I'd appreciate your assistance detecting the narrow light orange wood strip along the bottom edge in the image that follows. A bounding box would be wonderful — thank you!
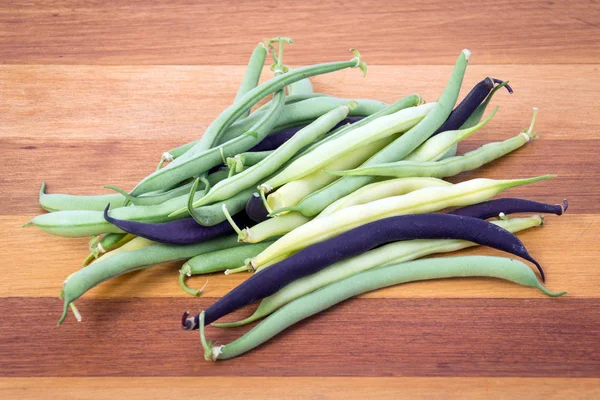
[0,376,600,400]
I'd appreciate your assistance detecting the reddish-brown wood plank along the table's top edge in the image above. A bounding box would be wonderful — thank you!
[0,0,600,65]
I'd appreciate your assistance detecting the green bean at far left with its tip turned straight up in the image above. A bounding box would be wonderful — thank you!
[39,182,127,211]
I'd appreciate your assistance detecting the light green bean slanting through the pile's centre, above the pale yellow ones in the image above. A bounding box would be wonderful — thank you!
[183,105,353,211]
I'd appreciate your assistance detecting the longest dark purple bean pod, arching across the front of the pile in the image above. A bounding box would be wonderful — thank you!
[182,214,544,330]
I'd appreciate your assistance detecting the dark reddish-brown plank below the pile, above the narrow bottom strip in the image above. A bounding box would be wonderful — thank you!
[0,298,600,378]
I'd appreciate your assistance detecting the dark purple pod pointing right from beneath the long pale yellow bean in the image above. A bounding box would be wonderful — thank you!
[449,198,569,219]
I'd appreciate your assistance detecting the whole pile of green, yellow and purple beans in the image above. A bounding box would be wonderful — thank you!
[27,37,568,361]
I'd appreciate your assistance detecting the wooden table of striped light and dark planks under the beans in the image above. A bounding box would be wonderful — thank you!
[0,0,600,400]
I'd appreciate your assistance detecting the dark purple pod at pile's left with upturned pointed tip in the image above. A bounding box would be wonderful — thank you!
[104,204,248,244]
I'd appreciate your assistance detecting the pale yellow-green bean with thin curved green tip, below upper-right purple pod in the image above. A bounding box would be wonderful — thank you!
[403,107,498,162]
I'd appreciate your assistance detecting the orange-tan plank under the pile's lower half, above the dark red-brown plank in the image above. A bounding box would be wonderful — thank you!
[0,214,600,296]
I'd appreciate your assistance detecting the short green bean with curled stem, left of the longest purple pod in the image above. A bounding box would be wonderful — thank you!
[179,242,271,296]
